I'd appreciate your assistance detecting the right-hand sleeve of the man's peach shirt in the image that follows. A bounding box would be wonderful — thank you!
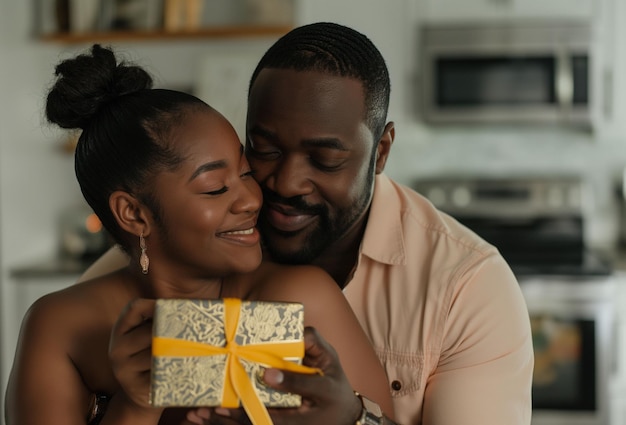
[423,254,534,425]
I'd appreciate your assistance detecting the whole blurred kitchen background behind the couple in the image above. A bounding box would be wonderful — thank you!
[0,0,626,425]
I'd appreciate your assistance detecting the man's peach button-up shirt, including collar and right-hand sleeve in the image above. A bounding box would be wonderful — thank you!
[344,175,533,425]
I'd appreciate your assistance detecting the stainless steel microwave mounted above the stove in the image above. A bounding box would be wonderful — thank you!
[420,21,592,126]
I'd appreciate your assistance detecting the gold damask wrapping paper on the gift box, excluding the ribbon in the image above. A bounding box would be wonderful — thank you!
[151,299,304,407]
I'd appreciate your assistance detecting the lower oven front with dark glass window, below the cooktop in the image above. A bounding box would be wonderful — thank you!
[519,276,616,425]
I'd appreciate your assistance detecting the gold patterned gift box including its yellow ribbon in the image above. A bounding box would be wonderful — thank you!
[150,298,318,423]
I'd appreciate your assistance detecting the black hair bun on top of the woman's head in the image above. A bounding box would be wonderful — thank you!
[46,44,152,129]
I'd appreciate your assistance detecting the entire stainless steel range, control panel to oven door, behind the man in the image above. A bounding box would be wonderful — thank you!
[415,176,617,425]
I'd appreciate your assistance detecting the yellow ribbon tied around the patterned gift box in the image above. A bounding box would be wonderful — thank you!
[152,298,322,425]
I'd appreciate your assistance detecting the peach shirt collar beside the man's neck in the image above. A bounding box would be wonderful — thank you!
[361,174,406,265]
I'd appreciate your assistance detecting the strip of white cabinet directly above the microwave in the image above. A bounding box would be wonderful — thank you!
[422,0,595,23]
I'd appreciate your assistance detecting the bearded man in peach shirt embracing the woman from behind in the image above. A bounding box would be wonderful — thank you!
[81,23,533,425]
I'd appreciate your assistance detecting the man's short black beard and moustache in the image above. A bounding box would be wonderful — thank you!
[258,164,374,264]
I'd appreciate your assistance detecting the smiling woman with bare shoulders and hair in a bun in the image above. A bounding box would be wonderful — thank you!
[7,45,392,425]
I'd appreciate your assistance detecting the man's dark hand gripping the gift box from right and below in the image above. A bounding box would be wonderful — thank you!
[187,327,361,425]
